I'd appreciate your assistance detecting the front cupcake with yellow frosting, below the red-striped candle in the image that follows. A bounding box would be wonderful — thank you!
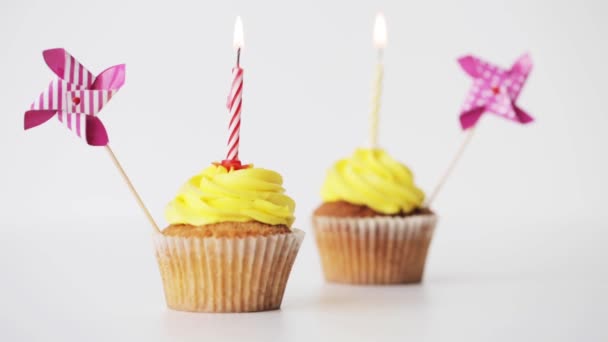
[154,164,304,312]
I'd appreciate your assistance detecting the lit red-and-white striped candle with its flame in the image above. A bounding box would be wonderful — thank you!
[226,17,243,164]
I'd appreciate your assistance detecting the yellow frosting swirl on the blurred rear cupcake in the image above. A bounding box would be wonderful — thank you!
[321,149,424,214]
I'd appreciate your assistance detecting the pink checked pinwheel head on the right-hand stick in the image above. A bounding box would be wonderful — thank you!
[458,54,534,130]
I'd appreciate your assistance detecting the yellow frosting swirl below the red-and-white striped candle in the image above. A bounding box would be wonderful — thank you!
[165,165,295,227]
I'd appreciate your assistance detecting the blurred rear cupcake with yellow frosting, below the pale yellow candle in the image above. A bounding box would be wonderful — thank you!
[313,148,437,284]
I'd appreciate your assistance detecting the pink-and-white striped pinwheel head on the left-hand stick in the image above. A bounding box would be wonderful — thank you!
[24,49,125,146]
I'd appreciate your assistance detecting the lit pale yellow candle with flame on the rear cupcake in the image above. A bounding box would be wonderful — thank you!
[369,13,386,148]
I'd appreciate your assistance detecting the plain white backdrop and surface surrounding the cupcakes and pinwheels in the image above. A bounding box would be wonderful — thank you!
[0,0,608,341]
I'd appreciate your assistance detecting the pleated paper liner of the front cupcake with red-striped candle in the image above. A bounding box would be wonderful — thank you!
[154,229,304,312]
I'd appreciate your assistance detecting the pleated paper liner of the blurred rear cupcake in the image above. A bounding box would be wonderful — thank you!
[313,215,437,285]
